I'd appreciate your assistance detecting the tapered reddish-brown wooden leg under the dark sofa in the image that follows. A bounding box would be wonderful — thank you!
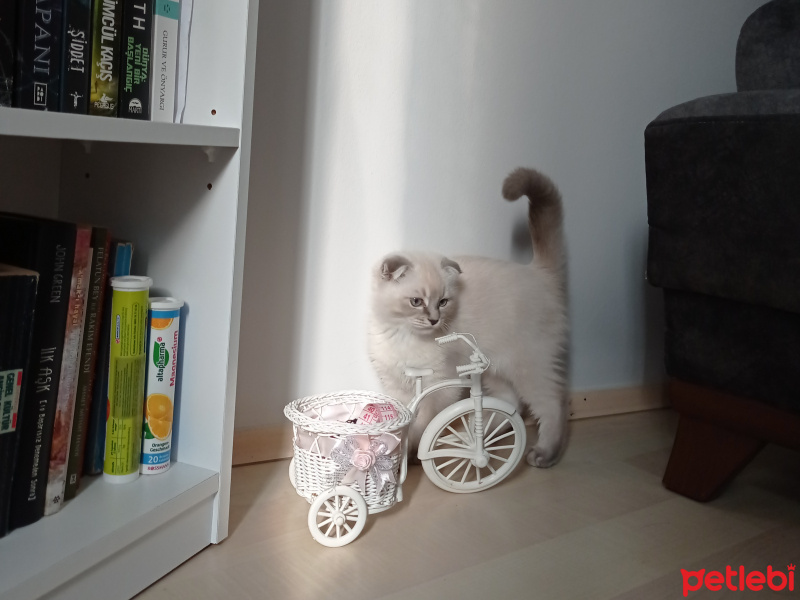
[663,415,765,502]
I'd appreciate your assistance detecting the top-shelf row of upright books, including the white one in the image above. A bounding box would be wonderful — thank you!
[0,0,192,123]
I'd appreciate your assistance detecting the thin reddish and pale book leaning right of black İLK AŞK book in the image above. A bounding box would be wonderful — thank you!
[44,225,92,516]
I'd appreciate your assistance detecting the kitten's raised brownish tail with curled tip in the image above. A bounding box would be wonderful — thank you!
[503,167,566,270]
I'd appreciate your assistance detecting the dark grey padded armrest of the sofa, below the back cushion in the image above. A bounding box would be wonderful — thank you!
[645,90,800,312]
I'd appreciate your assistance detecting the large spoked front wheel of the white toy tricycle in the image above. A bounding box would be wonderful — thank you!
[419,397,526,493]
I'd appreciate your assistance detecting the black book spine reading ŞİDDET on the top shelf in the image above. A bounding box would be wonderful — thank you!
[61,0,92,115]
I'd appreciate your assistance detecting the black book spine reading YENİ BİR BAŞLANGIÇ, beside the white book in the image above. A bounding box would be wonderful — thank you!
[120,0,153,120]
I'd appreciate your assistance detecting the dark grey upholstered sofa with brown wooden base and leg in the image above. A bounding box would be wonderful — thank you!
[645,0,800,501]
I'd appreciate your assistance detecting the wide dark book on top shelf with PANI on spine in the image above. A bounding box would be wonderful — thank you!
[13,0,63,111]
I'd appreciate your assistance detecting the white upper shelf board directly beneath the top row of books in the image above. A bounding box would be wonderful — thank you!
[0,107,240,148]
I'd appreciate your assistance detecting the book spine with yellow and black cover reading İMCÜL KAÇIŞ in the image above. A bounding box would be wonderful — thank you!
[89,0,122,117]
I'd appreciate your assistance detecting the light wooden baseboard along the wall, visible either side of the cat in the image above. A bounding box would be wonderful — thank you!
[233,384,668,466]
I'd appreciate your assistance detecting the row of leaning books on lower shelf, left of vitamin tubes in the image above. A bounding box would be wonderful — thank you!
[0,213,132,537]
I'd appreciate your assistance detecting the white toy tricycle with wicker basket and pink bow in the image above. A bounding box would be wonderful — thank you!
[284,333,526,547]
